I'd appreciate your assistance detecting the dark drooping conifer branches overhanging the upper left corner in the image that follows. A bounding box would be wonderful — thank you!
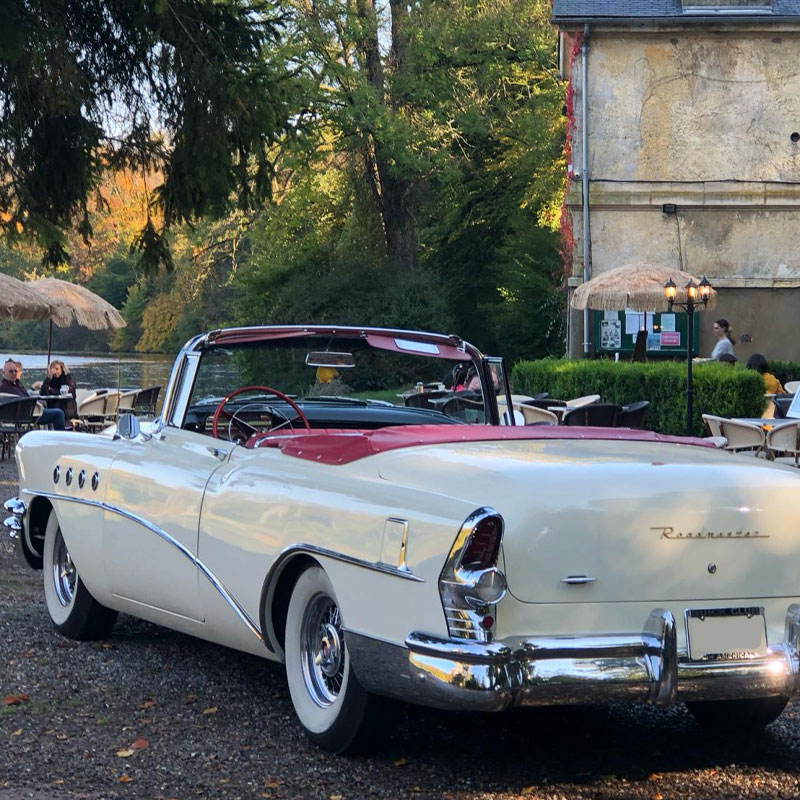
[0,0,294,268]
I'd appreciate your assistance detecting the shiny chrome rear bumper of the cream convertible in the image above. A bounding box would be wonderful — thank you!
[346,605,800,711]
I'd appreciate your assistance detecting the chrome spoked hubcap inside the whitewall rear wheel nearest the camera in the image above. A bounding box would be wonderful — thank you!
[301,595,344,707]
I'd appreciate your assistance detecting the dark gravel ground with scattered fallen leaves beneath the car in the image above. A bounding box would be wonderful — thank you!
[0,461,800,800]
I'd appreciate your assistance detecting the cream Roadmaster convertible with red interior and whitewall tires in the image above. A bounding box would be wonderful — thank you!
[5,326,800,752]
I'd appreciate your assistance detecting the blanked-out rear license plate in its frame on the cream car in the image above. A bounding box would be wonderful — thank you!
[686,606,767,661]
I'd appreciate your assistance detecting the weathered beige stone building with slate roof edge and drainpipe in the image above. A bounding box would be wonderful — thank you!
[552,0,800,361]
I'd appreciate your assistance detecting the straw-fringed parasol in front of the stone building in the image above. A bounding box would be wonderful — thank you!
[570,262,717,311]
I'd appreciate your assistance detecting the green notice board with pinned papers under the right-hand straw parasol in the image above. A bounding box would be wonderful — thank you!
[592,309,699,356]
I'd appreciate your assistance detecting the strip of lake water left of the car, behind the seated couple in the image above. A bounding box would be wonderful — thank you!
[0,352,175,400]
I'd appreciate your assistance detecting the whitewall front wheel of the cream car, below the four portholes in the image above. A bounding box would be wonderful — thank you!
[42,511,117,641]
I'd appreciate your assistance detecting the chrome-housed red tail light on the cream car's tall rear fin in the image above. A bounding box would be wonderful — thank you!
[439,508,507,642]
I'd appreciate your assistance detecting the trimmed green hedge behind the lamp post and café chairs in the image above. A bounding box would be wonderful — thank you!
[511,358,765,436]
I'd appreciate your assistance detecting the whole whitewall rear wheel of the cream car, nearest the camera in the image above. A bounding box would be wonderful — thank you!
[285,567,377,754]
